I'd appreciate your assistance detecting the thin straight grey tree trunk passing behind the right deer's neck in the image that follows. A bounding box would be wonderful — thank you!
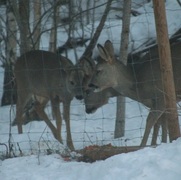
[114,0,131,138]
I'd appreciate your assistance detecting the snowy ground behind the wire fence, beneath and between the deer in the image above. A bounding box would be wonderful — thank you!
[0,86,180,159]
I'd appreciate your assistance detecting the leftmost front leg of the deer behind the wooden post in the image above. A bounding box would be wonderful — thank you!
[140,109,162,147]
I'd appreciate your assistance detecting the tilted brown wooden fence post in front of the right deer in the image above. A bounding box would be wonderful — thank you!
[153,0,180,141]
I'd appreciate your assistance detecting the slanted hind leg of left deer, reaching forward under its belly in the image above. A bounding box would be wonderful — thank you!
[35,102,59,143]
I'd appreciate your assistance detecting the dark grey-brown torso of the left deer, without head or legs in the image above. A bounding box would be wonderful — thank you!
[14,50,80,101]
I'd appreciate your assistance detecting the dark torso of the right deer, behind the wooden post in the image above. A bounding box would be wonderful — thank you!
[130,42,181,102]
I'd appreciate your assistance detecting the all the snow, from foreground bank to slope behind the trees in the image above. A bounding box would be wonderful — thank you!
[0,0,181,180]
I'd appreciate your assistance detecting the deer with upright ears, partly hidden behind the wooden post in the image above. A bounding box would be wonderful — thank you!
[89,40,181,147]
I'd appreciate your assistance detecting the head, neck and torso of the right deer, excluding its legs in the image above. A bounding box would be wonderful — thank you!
[90,42,181,107]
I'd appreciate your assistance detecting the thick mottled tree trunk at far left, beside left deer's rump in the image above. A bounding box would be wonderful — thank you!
[1,1,17,106]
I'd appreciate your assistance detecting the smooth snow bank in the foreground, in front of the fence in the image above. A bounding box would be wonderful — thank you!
[0,139,181,180]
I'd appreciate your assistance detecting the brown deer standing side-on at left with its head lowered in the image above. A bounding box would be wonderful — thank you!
[14,50,83,149]
